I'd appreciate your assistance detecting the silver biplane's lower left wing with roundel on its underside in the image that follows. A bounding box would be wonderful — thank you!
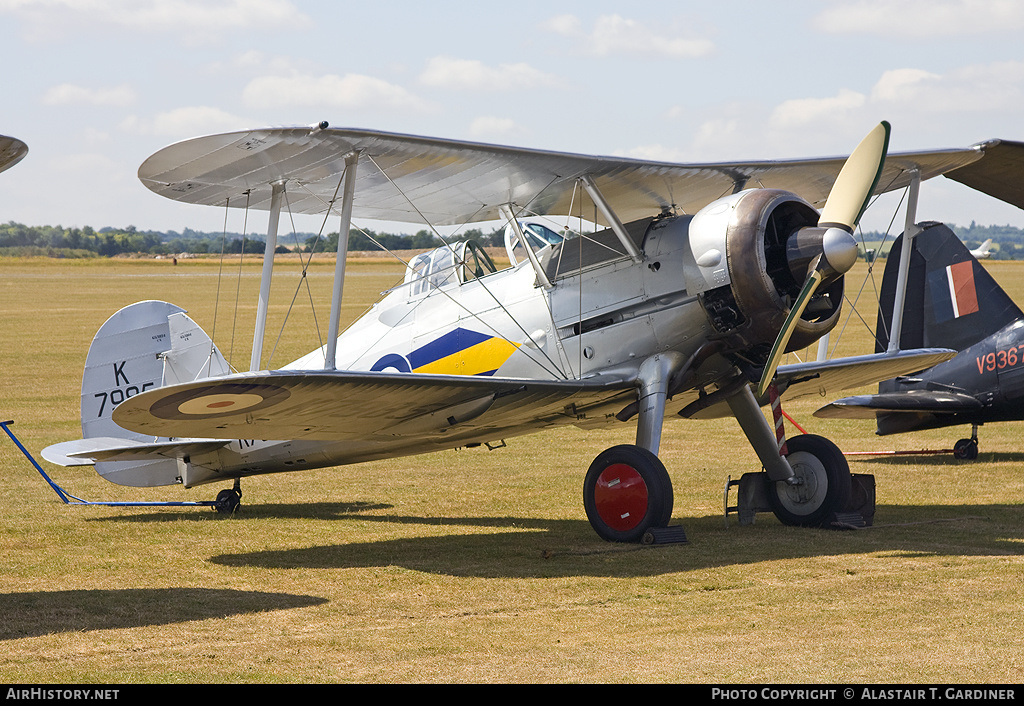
[114,371,636,444]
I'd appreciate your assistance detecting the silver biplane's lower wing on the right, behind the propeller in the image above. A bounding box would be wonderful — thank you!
[761,348,956,404]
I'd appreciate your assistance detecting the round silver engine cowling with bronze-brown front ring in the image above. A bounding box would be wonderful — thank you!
[689,189,844,354]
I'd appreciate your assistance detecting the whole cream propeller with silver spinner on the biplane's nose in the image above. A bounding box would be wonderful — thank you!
[757,121,889,398]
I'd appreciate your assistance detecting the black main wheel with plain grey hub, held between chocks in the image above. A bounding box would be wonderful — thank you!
[768,434,851,527]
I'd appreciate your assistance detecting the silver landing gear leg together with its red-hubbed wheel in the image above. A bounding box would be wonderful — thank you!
[583,352,683,542]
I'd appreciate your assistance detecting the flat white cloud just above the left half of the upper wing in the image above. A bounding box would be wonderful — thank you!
[242,74,430,111]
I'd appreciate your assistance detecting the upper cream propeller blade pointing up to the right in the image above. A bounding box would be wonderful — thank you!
[818,120,890,233]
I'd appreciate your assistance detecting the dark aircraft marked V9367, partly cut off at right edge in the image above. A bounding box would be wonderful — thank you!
[814,222,1024,459]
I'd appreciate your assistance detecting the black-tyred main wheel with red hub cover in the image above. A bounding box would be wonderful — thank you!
[583,444,673,542]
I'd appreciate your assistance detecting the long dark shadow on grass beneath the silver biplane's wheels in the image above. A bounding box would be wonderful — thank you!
[208,505,1024,578]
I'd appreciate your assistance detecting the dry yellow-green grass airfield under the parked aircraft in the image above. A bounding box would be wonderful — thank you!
[0,256,1024,683]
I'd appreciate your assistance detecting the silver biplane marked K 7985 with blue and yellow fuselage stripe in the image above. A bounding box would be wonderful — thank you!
[43,123,1024,541]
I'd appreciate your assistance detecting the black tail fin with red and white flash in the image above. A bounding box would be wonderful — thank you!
[876,222,1024,352]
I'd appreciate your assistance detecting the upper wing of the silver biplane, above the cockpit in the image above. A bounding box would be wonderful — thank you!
[138,128,988,224]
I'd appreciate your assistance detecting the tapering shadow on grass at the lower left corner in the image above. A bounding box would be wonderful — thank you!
[0,588,327,640]
